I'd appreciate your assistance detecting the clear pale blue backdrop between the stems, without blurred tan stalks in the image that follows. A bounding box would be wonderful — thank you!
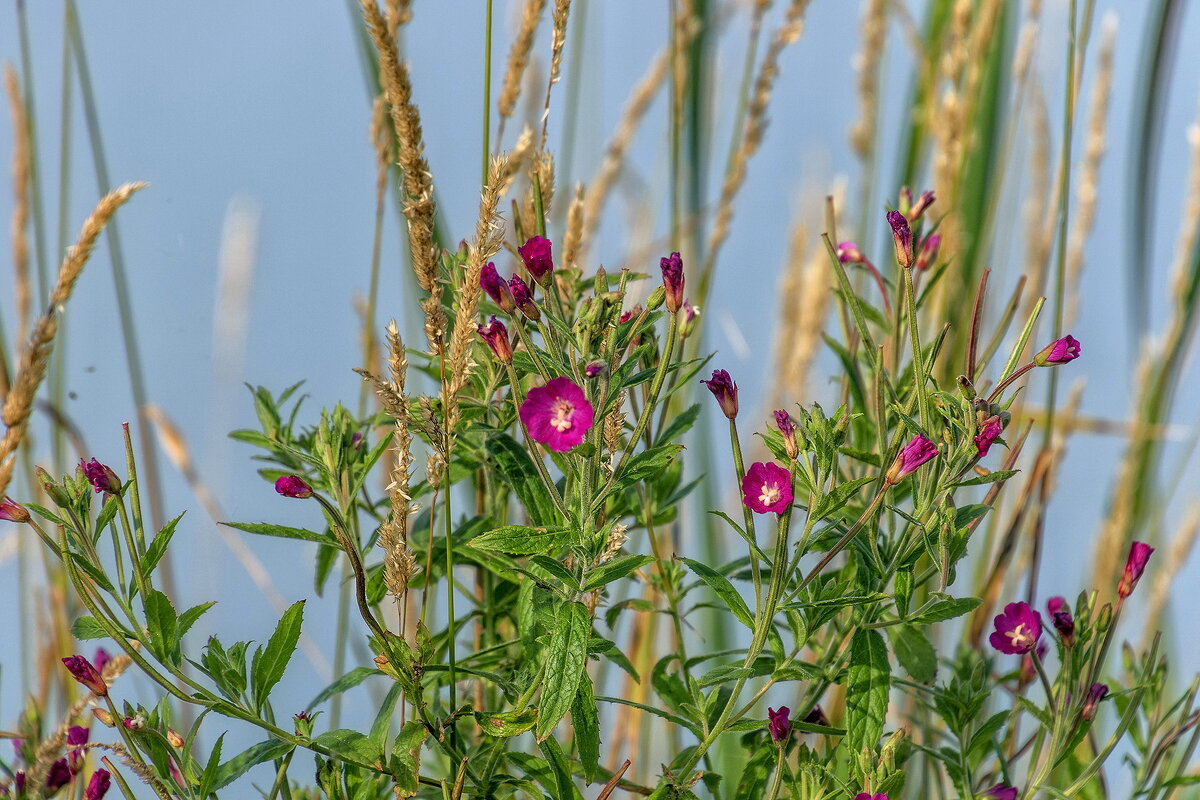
[0,0,1200,796]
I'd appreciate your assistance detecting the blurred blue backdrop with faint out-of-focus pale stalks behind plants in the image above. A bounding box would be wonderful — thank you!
[0,0,1200,786]
